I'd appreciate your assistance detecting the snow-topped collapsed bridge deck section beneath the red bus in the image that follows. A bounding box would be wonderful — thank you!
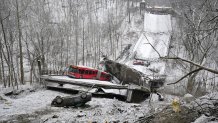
[41,75,150,103]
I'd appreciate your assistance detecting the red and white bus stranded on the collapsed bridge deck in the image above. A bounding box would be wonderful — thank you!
[64,65,111,81]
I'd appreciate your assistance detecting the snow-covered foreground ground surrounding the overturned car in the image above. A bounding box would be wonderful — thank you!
[0,85,177,123]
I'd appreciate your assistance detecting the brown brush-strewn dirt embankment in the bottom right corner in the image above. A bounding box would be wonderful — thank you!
[139,93,218,123]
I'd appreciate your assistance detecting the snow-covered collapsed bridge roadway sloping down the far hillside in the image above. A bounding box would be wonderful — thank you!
[121,13,172,75]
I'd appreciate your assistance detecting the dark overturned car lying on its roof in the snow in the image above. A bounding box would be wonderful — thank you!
[51,93,92,107]
